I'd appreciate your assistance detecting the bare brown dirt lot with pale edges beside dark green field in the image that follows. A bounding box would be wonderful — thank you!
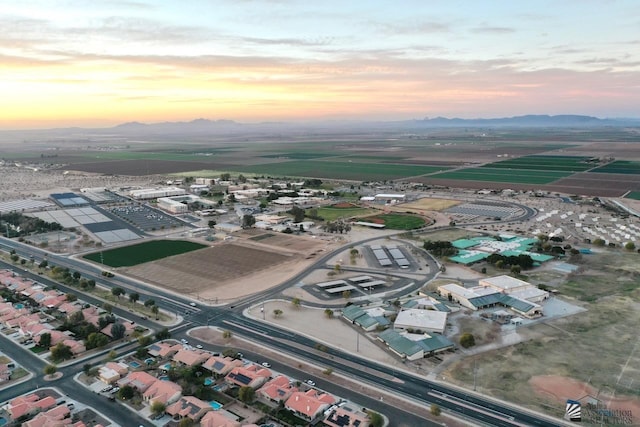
[120,233,327,304]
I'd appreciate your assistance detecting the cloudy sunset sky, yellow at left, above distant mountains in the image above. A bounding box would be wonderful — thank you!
[0,0,640,129]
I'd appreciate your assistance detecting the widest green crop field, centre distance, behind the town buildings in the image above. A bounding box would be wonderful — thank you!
[234,158,446,181]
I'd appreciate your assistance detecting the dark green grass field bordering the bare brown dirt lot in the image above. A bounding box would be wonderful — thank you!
[84,240,207,267]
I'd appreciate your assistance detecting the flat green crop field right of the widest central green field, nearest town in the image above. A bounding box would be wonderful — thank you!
[431,168,572,184]
